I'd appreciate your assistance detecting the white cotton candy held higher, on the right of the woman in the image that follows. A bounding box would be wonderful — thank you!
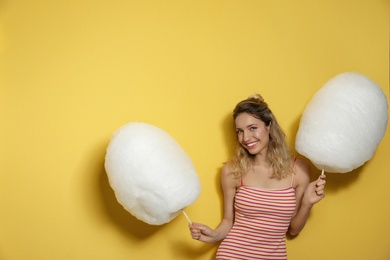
[295,72,388,173]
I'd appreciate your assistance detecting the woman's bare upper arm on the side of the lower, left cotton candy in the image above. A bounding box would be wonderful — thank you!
[221,164,238,222]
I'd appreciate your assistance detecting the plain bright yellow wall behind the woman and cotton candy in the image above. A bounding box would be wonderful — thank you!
[0,0,390,260]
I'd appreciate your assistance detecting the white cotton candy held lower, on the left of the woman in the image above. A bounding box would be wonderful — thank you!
[105,122,201,225]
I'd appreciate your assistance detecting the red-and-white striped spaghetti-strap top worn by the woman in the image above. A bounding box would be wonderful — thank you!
[216,186,296,260]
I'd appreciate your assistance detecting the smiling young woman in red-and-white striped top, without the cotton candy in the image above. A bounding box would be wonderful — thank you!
[189,94,325,259]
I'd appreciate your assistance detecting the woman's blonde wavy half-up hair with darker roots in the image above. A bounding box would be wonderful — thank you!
[227,94,293,180]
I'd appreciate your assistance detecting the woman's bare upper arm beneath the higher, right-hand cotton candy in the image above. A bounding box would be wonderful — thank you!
[294,159,311,215]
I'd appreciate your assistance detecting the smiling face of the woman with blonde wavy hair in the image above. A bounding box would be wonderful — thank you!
[235,113,271,155]
